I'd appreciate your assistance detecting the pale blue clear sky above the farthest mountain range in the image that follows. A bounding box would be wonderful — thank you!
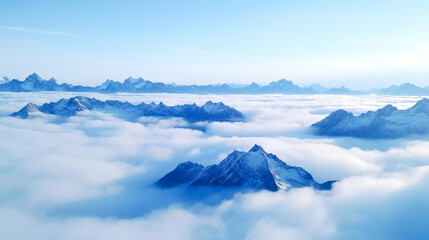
[0,0,429,89]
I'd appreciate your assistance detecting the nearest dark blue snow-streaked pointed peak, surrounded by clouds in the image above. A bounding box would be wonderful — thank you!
[155,145,335,191]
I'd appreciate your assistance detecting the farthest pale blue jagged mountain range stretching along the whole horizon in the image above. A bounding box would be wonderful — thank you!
[0,73,429,95]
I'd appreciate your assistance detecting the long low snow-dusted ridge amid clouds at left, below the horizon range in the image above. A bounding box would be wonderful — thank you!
[11,96,244,123]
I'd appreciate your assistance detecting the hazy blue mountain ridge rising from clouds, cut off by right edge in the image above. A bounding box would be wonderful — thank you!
[312,98,429,138]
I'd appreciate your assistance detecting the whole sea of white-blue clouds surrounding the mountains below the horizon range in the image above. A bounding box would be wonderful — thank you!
[0,92,429,239]
